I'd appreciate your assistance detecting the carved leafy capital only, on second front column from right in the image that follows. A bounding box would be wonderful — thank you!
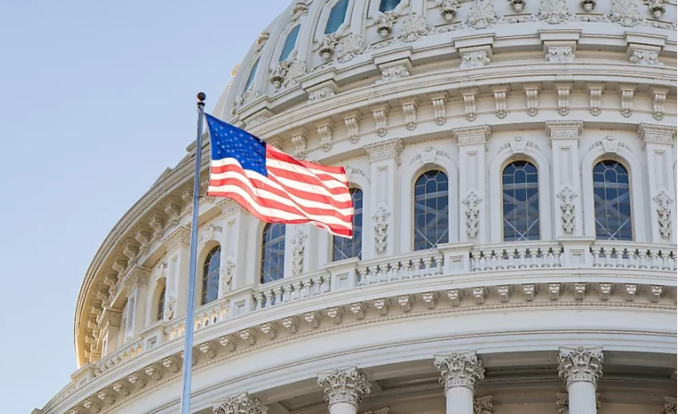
[434,351,485,390]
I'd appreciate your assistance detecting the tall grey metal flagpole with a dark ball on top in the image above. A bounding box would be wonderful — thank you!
[181,92,206,414]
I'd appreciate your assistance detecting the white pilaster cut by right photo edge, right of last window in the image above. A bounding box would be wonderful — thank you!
[637,124,676,244]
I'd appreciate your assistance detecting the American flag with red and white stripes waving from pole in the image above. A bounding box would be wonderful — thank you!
[205,115,353,238]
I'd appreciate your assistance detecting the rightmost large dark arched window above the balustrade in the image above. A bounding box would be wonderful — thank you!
[593,160,633,240]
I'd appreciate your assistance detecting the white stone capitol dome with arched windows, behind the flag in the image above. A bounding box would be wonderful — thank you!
[36,0,678,414]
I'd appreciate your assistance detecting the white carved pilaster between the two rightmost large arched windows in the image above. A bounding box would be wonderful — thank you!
[545,121,584,239]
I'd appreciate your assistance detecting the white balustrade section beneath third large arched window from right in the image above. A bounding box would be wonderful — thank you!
[358,250,444,286]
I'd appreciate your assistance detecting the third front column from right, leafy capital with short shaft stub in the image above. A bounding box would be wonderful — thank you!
[318,367,370,414]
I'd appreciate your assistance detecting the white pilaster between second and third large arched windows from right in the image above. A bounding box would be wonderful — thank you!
[452,125,492,243]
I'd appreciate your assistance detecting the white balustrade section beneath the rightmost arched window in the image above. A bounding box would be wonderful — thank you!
[590,242,676,270]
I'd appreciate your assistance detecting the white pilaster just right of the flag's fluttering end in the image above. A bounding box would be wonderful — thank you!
[363,138,403,260]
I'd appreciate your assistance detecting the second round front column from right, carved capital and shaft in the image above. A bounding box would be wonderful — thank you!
[434,351,485,414]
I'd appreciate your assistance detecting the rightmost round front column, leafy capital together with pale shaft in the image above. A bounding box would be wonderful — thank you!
[558,347,603,414]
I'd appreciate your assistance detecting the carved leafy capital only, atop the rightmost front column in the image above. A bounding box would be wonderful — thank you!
[558,346,603,386]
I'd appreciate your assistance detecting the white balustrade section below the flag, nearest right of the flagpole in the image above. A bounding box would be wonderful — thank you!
[252,270,332,309]
